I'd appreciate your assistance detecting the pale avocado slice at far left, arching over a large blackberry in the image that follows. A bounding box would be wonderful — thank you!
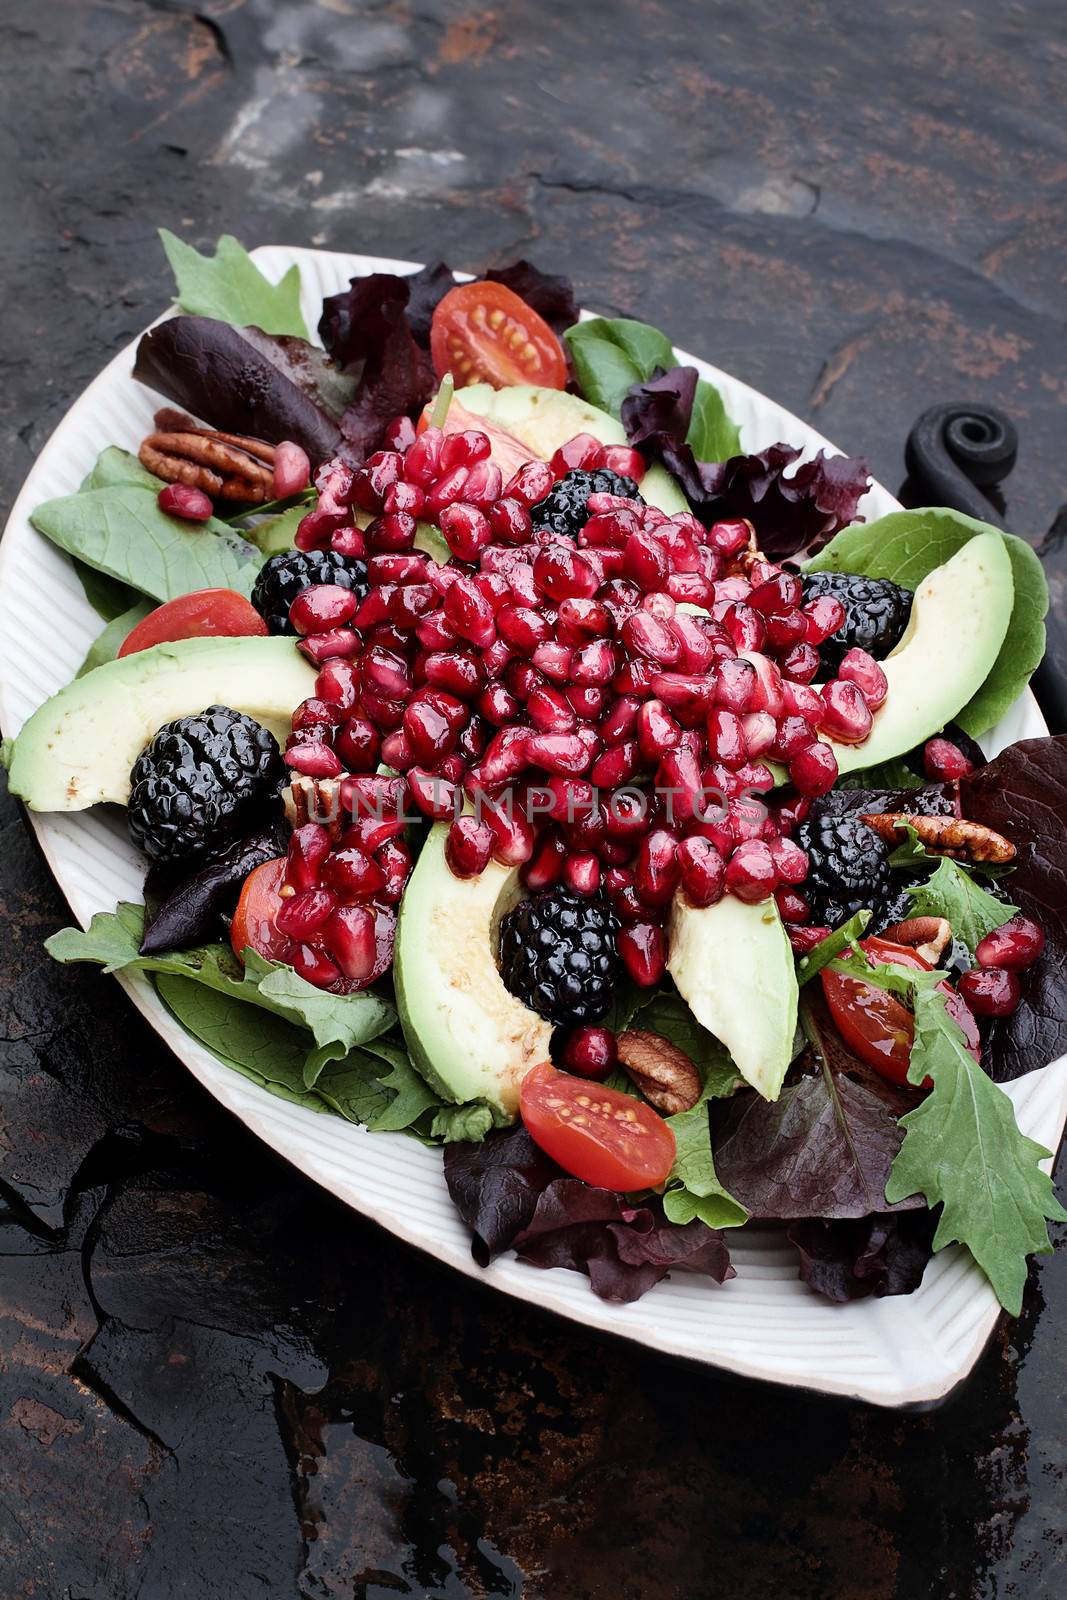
[5,638,315,811]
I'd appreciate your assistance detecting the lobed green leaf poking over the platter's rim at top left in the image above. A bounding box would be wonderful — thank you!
[160,227,307,339]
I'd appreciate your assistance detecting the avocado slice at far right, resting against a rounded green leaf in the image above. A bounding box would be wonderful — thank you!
[833,531,1014,773]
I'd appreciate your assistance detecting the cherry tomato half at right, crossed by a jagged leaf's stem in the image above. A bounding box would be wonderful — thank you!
[822,938,981,1088]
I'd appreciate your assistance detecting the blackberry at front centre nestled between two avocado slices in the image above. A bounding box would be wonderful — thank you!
[499,890,619,1027]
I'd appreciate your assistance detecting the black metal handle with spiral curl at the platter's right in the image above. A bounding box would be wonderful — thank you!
[904,400,1067,733]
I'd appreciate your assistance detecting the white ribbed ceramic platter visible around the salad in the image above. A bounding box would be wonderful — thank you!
[0,246,1067,1406]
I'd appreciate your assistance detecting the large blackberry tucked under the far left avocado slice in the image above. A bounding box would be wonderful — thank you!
[128,706,285,862]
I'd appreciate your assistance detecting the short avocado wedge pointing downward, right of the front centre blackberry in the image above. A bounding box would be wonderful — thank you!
[667,893,798,1099]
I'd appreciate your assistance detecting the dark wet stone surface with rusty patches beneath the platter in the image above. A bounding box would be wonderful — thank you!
[0,0,1067,1600]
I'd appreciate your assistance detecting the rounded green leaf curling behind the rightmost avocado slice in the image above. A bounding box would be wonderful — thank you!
[806,507,1048,736]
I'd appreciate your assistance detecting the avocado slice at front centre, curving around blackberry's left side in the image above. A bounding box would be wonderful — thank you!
[394,822,552,1120]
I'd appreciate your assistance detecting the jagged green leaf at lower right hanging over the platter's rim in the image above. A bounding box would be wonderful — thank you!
[886,987,1067,1317]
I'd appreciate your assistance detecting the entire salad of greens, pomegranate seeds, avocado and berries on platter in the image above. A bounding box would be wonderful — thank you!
[3,234,1067,1312]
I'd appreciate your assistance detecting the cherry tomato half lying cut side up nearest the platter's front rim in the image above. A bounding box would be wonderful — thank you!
[518,1061,675,1194]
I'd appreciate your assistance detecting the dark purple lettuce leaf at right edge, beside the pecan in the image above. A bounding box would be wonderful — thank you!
[960,734,1067,1083]
